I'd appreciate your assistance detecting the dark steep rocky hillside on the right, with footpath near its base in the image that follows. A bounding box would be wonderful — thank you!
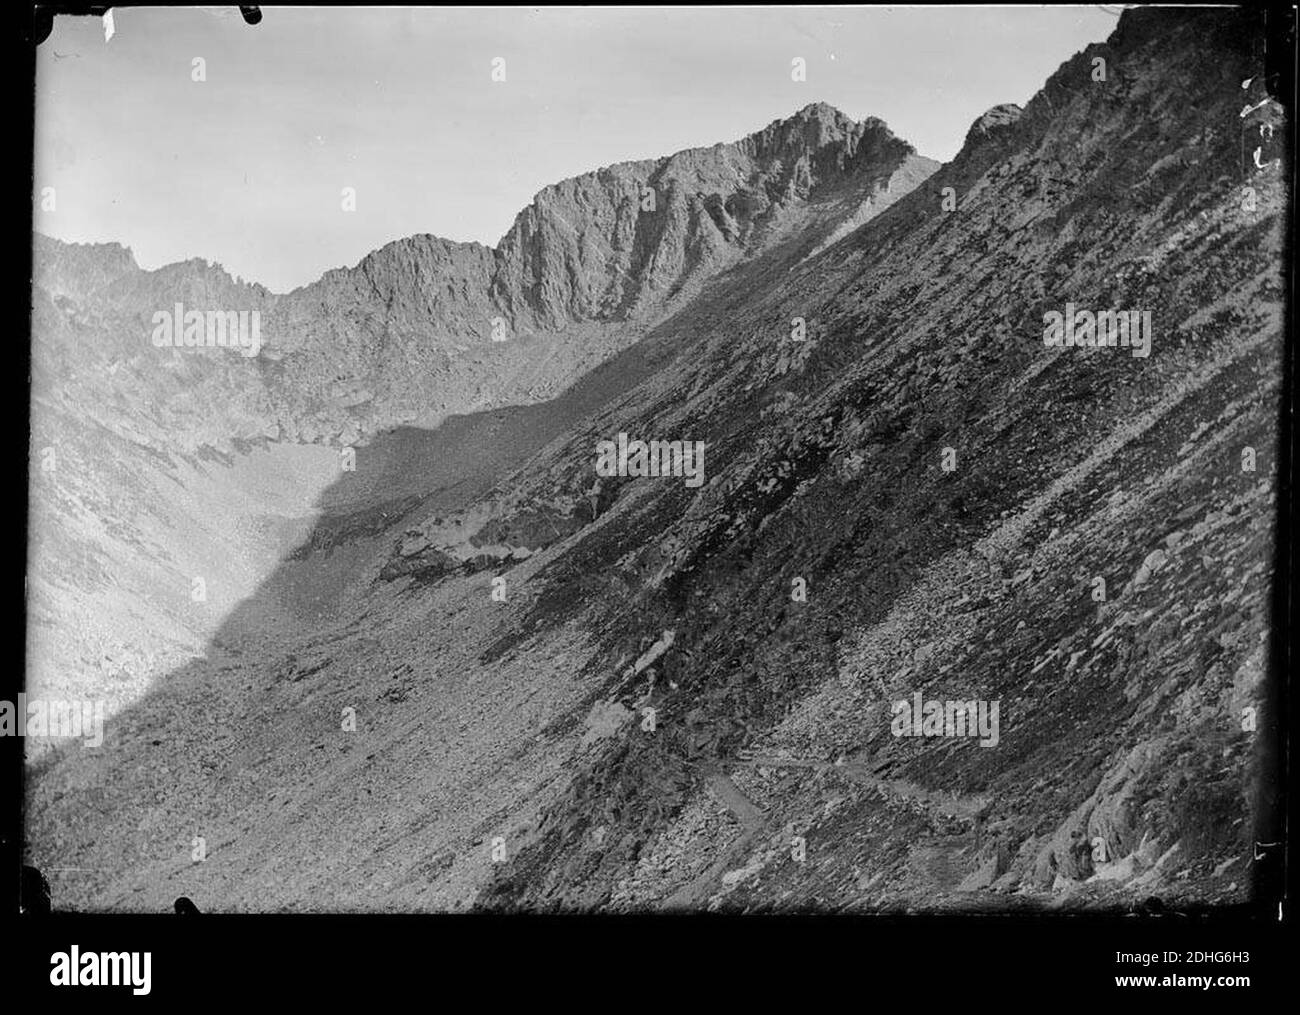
[460,5,1286,908]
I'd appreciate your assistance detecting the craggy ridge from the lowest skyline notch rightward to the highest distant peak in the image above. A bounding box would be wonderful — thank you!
[258,105,937,441]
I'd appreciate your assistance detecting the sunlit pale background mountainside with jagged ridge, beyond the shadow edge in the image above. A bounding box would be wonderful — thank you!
[29,105,937,743]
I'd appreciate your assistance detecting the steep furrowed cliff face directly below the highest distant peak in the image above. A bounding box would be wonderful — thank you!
[494,103,937,326]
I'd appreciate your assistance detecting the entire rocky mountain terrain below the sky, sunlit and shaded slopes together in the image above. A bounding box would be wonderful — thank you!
[27,9,1291,912]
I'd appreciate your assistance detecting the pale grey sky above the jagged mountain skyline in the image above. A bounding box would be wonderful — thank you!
[34,6,1117,291]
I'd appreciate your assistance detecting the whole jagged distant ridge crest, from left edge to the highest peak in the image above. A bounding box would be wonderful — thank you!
[34,104,937,451]
